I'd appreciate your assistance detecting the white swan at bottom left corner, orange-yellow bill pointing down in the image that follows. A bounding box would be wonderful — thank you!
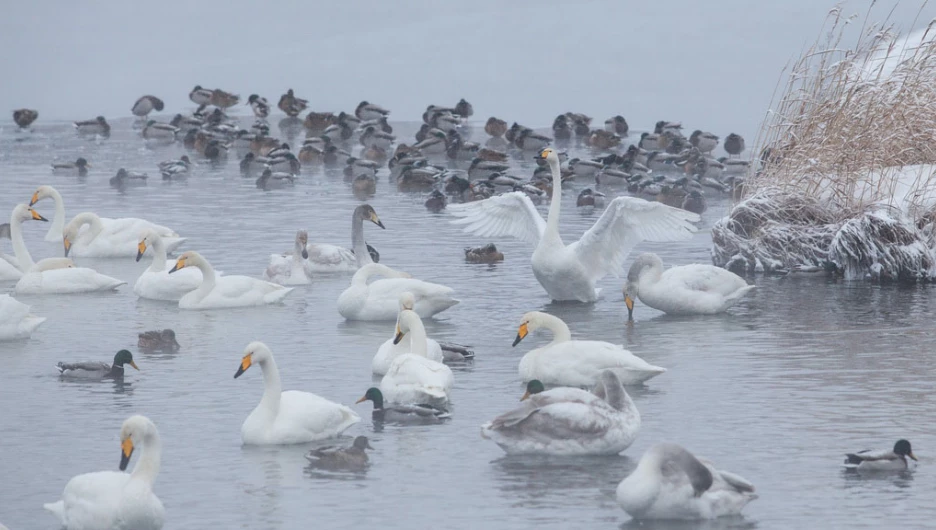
[45,416,166,530]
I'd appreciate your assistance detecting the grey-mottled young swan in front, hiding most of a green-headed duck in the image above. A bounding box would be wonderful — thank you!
[481,370,640,455]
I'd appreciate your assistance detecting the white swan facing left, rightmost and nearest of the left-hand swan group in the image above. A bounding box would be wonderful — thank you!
[169,250,293,309]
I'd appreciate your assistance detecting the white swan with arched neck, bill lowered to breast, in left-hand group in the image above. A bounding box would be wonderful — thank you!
[62,212,185,258]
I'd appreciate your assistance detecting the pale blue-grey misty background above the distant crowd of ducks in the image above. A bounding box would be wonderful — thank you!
[0,0,936,136]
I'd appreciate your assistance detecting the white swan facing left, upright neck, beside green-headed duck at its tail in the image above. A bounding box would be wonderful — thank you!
[234,342,361,445]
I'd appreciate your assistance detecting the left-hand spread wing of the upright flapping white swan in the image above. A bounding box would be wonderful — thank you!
[448,191,546,244]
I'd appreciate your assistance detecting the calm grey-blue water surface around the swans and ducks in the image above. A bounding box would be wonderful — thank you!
[0,117,936,530]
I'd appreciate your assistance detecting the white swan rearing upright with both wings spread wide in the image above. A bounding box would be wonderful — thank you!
[449,148,699,302]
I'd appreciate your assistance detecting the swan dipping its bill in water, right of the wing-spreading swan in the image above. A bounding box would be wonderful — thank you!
[624,253,754,320]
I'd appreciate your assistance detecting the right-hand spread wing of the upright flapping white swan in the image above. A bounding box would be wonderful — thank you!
[568,197,699,282]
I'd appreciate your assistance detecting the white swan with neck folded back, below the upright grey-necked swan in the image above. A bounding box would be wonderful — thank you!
[338,263,458,320]
